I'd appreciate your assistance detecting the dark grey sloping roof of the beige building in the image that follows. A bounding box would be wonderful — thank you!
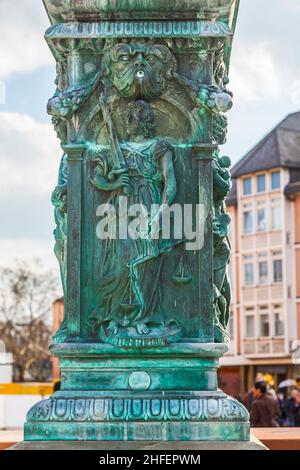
[229,112,300,180]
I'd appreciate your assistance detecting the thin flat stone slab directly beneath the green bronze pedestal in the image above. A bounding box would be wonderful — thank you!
[8,436,268,451]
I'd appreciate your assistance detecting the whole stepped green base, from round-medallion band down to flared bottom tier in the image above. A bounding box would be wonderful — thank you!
[25,344,250,441]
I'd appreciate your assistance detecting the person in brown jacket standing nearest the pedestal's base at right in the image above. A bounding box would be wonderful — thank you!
[250,382,279,428]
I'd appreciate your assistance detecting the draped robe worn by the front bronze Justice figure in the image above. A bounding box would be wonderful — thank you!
[90,139,176,327]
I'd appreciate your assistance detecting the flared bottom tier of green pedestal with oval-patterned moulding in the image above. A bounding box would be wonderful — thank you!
[25,391,250,441]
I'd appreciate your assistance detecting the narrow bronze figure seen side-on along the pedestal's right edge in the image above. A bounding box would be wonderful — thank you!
[213,155,231,342]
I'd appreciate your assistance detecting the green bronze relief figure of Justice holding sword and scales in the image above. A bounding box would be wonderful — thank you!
[90,100,183,346]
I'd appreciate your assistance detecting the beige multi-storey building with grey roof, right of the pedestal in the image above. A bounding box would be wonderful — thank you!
[220,112,300,395]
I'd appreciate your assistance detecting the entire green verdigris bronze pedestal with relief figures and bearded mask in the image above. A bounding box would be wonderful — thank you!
[25,0,249,441]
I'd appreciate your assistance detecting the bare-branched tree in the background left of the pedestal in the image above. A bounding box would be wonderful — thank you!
[0,261,61,381]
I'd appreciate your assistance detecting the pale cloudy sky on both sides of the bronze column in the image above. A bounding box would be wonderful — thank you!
[0,0,300,266]
